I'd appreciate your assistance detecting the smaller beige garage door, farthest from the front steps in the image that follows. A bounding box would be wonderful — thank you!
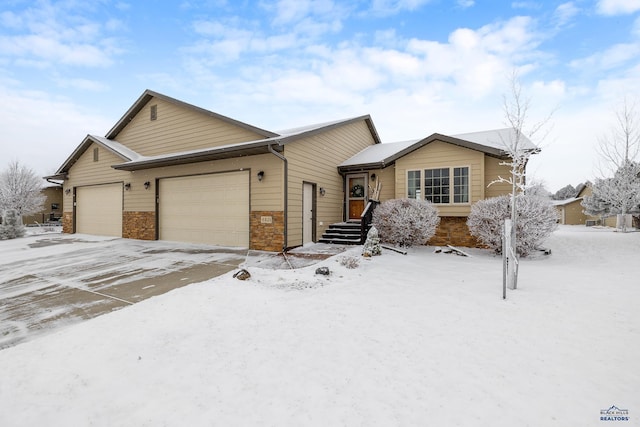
[76,183,122,237]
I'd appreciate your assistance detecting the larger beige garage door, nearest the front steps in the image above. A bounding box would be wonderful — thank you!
[158,171,249,248]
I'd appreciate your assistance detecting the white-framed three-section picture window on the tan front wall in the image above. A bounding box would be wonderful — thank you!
[407,166,469,204]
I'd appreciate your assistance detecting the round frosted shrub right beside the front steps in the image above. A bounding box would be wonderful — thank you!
[373,199,440,247]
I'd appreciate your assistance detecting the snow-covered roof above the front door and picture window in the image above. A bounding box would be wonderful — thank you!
[338,128,539,172]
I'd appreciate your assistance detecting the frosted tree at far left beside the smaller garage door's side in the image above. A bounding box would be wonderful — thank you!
[0,161,45,221]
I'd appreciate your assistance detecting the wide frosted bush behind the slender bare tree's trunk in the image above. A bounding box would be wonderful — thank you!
[467,194,558,256]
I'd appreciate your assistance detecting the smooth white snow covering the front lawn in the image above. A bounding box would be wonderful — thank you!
[0,226,640,426]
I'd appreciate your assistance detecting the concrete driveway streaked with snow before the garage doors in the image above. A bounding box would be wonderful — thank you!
[0,234,246,349]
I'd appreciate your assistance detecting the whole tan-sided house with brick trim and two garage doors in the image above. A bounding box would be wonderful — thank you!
[47,90,535,251]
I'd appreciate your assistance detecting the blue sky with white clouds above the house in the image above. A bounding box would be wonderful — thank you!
[0,0,640,191]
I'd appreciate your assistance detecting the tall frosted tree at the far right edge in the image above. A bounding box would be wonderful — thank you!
[592,98,640,232]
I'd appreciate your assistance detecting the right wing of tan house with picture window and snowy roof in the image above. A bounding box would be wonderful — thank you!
[338,129,538,246]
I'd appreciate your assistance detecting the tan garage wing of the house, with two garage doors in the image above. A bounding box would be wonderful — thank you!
[47,90,380,251]
